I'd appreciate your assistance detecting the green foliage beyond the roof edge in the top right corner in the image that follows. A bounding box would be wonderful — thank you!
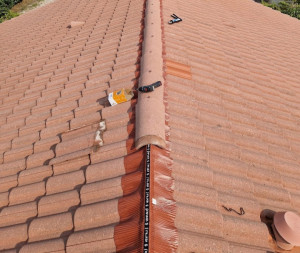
[262,0,300,19]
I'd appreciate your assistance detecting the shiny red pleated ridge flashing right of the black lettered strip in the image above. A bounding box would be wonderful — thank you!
[149,145,178,253]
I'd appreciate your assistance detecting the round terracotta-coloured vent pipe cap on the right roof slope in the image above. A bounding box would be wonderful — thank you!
[272,211,300,250]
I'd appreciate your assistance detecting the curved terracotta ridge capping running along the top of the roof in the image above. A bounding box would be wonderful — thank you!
[135,0,166,149]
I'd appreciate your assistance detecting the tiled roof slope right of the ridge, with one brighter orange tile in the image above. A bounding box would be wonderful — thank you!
[162,0,300,253]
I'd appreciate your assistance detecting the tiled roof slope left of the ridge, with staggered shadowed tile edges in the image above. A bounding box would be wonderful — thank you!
[0,0,144,253]
